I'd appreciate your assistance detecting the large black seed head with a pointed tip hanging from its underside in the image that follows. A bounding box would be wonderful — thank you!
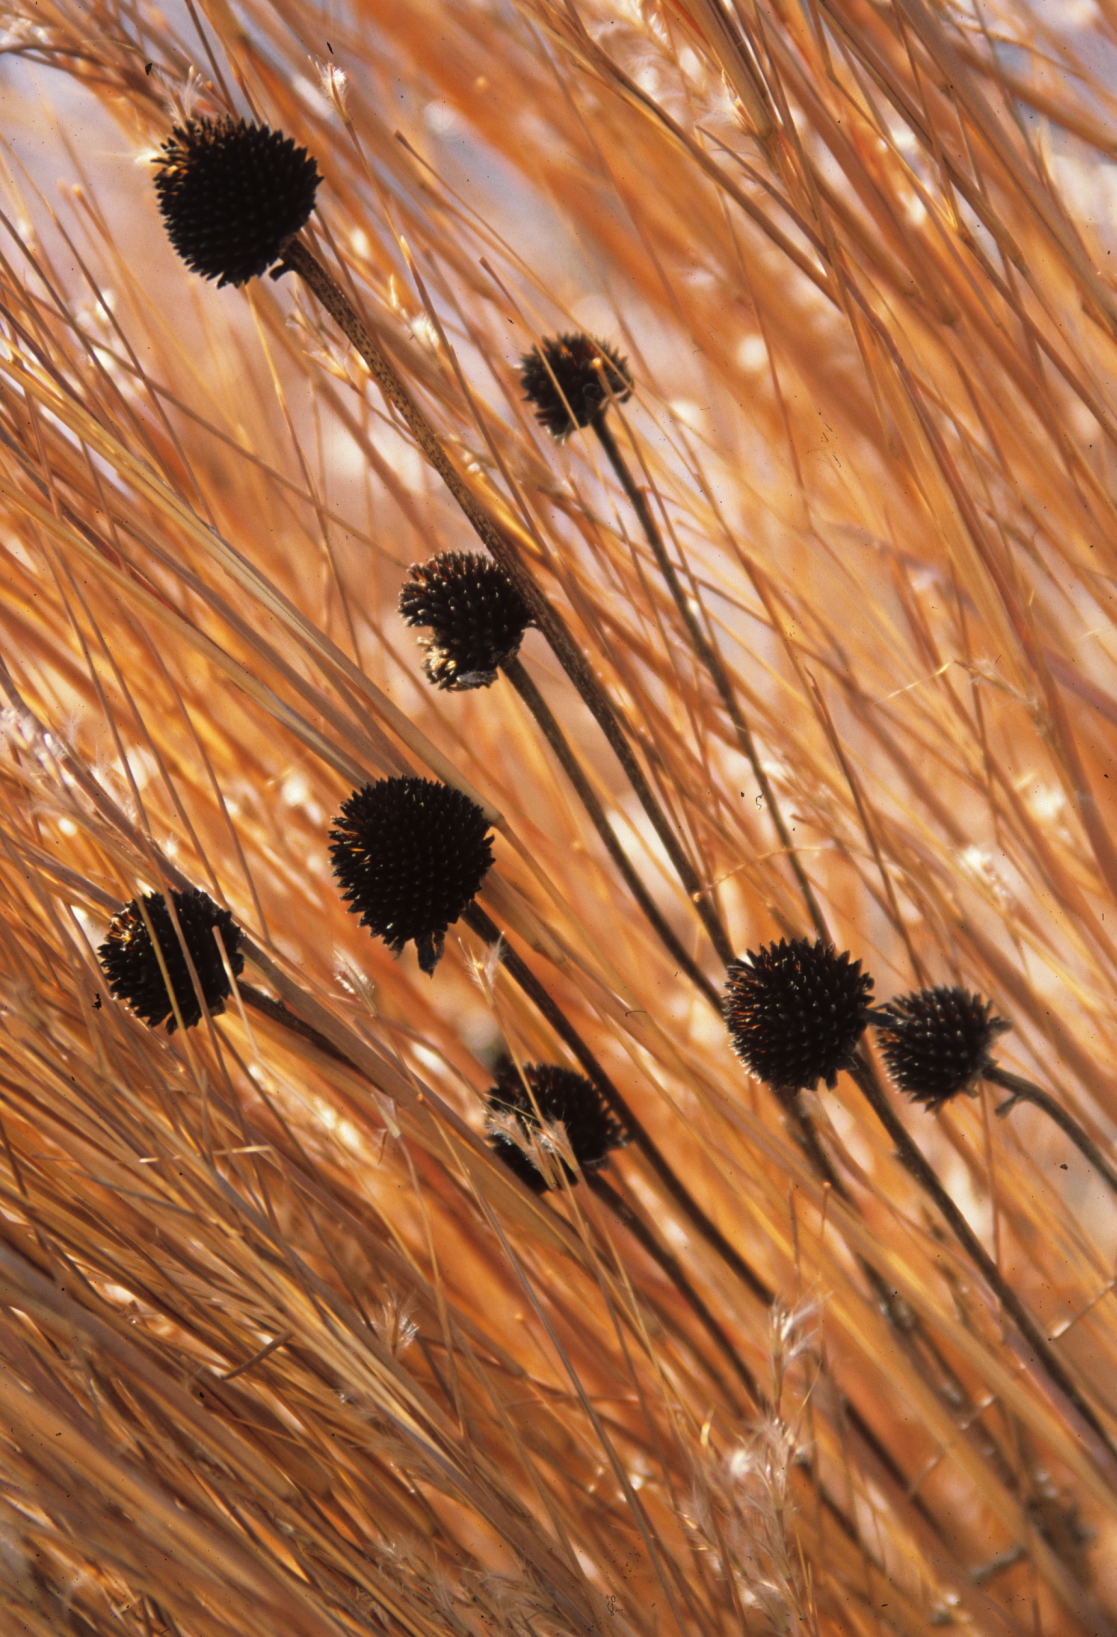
[329,779,493,972]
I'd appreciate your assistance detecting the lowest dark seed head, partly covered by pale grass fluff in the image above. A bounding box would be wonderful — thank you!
[488,1062,627,1193]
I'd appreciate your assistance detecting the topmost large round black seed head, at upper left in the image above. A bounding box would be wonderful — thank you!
[156,115,321,285]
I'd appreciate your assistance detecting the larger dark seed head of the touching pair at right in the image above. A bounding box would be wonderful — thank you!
[724,938,873,1092]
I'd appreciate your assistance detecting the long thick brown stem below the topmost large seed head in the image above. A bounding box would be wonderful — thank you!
[280,236,732,966]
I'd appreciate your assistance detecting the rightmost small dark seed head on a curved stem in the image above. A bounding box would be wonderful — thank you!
[876,987,1012,1108]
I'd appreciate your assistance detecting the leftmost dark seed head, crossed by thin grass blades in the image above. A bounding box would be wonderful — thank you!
[97,887,244,1035]
